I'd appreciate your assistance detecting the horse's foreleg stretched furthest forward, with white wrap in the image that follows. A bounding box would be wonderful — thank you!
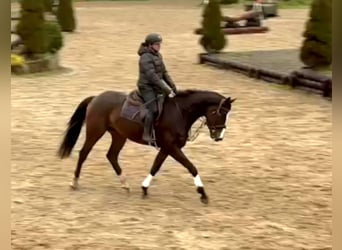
[170,147,208,204]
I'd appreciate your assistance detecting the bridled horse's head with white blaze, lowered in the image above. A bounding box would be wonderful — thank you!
[205,97,236,141]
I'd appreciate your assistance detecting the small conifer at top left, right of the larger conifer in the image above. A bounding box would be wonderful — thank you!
[57,0,76,32]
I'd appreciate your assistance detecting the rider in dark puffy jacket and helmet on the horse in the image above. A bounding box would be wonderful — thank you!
[137,33,177,143]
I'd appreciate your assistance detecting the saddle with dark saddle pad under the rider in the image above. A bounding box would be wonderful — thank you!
[120,90,165,125]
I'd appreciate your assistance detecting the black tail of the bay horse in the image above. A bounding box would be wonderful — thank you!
[57,96,95,159]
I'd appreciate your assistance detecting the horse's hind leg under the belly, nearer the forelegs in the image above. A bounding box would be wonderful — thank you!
[107,130,130,192]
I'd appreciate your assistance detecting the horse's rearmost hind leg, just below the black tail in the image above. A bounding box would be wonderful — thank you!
[70,120,106,189]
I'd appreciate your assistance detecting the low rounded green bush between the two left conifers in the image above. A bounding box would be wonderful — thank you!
[45,21,64,53]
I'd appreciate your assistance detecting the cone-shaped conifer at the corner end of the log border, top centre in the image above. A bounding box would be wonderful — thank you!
[200,0,227,53]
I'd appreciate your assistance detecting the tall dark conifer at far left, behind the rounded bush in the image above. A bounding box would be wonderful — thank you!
[16,0,47,55]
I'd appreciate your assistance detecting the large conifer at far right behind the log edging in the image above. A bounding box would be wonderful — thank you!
[300,0,332,68]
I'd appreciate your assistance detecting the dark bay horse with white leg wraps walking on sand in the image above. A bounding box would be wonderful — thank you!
[58,90,235,203]
